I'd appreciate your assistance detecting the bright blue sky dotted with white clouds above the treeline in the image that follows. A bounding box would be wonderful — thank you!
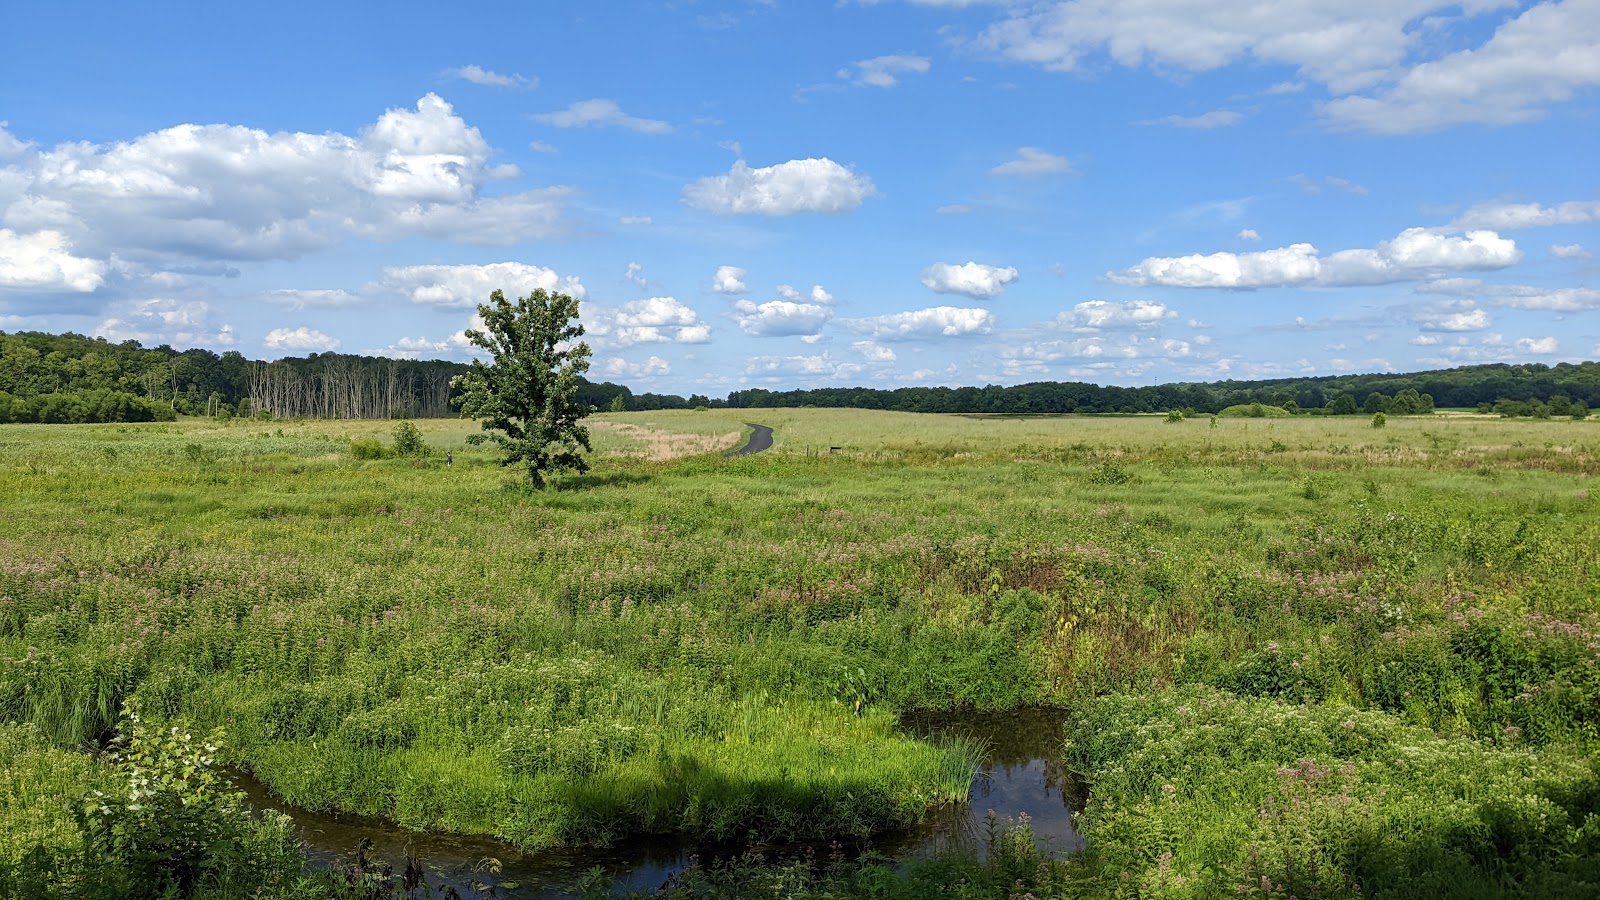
[0,0,1600,394]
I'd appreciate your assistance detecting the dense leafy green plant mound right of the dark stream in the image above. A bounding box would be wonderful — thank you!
[1067,689,1600,897]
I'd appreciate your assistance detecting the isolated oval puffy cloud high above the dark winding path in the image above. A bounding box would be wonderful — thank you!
[683,157,877,216]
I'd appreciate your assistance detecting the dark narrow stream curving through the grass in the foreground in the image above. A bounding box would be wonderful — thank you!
[238,709,1085,900]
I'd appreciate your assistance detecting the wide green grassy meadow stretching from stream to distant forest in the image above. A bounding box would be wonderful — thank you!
[0,410,1600,897]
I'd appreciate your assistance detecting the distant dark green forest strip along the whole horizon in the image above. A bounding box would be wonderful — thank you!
[0,331,1600,423]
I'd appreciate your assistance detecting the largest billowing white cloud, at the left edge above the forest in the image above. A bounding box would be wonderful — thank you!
[0,94,570,263]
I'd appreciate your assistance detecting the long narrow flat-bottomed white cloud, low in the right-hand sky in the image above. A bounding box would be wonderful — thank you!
[1106,227,1522,288]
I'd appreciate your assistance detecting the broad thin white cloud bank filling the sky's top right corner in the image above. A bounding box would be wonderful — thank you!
[947,0,1600,133]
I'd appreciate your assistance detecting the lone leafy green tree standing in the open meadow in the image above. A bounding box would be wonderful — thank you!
[453,288,594,487]
